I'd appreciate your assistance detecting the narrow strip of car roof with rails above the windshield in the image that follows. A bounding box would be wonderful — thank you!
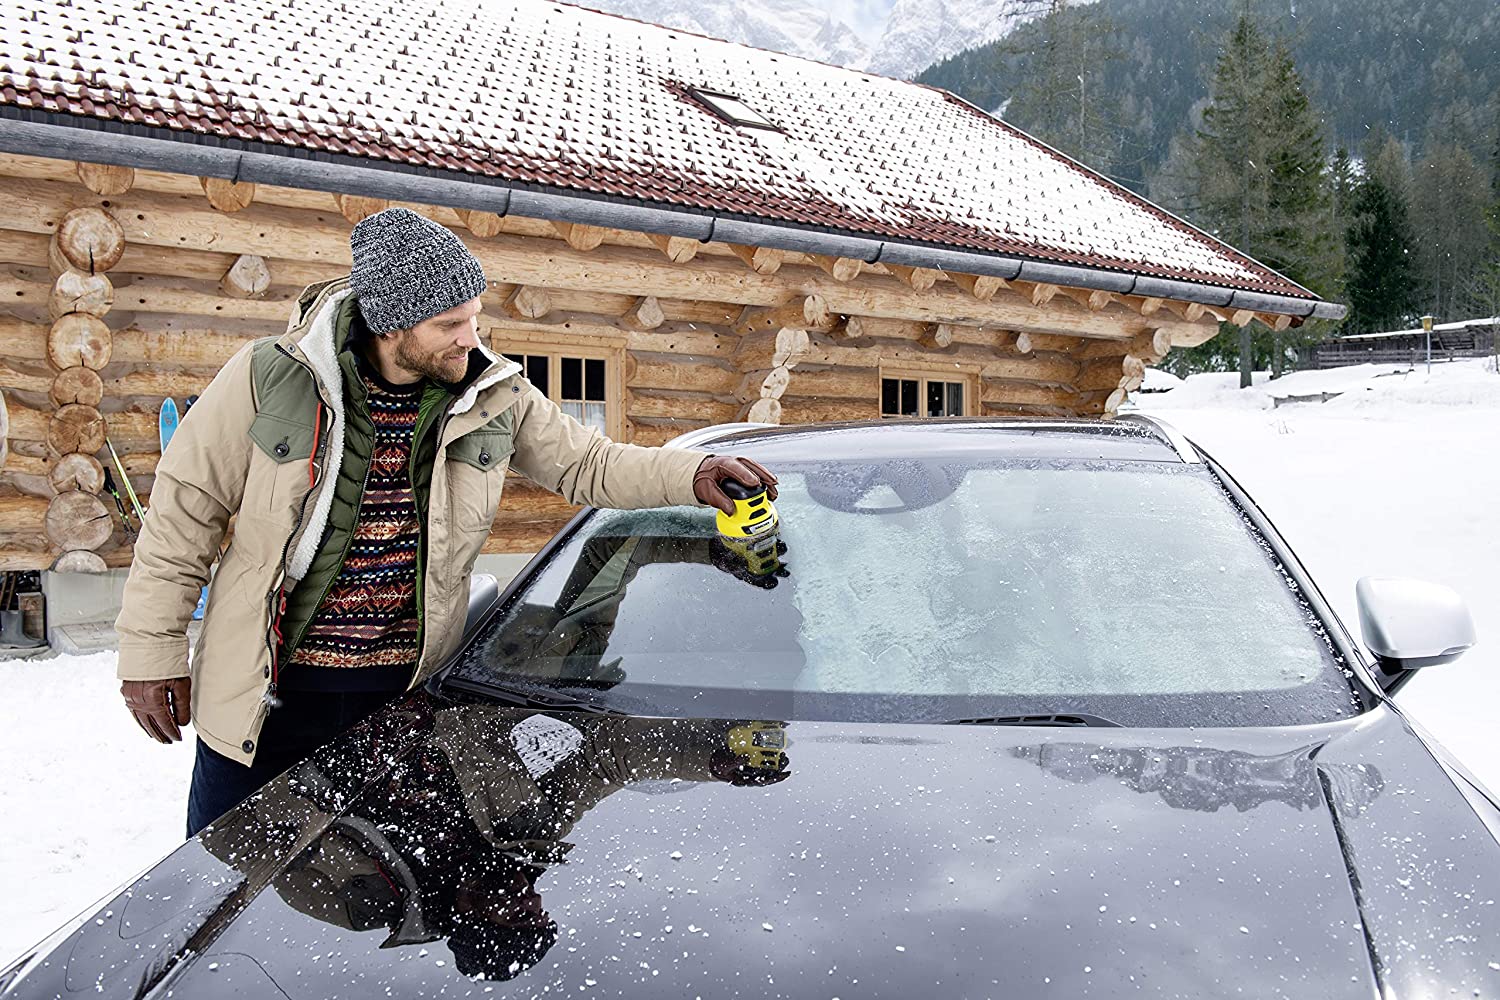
[668,414,1202,463]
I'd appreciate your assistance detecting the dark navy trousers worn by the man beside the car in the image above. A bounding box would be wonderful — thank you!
[188,691,399,838]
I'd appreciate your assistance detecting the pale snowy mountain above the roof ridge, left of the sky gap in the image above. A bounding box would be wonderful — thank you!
[564,0,870,69]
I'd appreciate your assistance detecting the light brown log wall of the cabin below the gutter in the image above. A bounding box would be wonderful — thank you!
[0,154,1224,571]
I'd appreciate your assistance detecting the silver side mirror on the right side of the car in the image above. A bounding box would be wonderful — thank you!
[1355,576,1476,691]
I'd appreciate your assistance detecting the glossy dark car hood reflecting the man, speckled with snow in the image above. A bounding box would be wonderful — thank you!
[12,696,1500,999]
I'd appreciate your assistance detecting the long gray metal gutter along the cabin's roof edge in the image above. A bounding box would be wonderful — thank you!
[0,116,1349,319]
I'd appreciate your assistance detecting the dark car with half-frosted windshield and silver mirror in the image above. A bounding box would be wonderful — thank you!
[0,415,1500,1000]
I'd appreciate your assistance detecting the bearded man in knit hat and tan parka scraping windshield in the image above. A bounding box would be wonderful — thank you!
[117,208,776,835]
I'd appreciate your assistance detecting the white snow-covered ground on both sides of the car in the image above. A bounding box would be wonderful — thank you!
[0,363,1500,964]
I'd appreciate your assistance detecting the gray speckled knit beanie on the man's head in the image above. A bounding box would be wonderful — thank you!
[350,208,486,333]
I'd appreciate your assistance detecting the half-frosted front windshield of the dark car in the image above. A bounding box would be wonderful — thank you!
[446,433,1359,726]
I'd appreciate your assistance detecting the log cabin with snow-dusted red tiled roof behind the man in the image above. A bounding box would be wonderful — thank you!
[0,0,1343,573]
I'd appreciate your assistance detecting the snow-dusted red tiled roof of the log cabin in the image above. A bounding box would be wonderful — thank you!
[0,0,1313,298]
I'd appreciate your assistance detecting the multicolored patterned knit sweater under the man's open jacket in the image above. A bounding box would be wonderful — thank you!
[287,363,426,690]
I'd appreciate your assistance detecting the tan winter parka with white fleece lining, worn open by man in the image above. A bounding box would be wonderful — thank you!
[116,277,704,765]
